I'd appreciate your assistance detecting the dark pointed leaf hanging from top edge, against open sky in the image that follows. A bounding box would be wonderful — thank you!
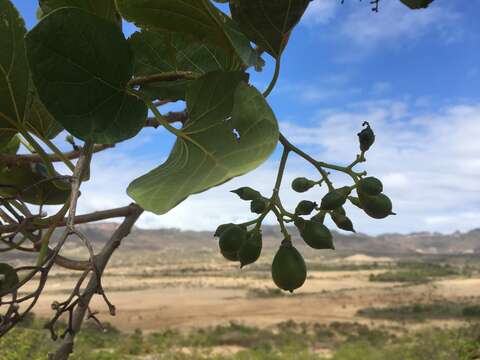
[230,0,311,58]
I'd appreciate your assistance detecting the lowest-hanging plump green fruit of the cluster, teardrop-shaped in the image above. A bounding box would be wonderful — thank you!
[272,240,307,292]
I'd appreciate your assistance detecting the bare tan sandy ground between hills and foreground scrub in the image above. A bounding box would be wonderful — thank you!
[25,254,480,331]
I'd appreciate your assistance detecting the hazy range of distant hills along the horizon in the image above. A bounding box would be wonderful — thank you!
[7,223,480,261]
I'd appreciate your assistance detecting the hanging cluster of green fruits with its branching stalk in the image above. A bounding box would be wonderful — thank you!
[214,122,394,292]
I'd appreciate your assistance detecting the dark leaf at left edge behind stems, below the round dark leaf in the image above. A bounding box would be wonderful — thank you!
[0,163,70,205]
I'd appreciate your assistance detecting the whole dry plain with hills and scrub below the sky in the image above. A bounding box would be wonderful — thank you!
[0,224,480,359]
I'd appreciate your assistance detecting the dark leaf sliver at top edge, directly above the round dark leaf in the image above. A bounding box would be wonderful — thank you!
[39,0,122,27]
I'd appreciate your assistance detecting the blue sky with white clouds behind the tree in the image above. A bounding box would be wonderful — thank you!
[13,0,480,235]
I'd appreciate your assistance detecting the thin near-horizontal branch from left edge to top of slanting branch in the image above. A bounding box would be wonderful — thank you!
[0,206,137,234]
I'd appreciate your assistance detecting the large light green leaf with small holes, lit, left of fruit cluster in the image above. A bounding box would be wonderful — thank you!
[128,72,278,214]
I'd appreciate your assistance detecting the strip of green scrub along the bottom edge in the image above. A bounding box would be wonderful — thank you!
[0,321,480,360]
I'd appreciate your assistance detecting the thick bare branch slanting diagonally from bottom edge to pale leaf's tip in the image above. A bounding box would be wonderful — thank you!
[49,204,143,360]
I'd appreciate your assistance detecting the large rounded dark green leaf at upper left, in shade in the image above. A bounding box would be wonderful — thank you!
[26,8,147,144]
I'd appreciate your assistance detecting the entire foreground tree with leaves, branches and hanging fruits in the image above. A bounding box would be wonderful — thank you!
[0,0,433,359]
